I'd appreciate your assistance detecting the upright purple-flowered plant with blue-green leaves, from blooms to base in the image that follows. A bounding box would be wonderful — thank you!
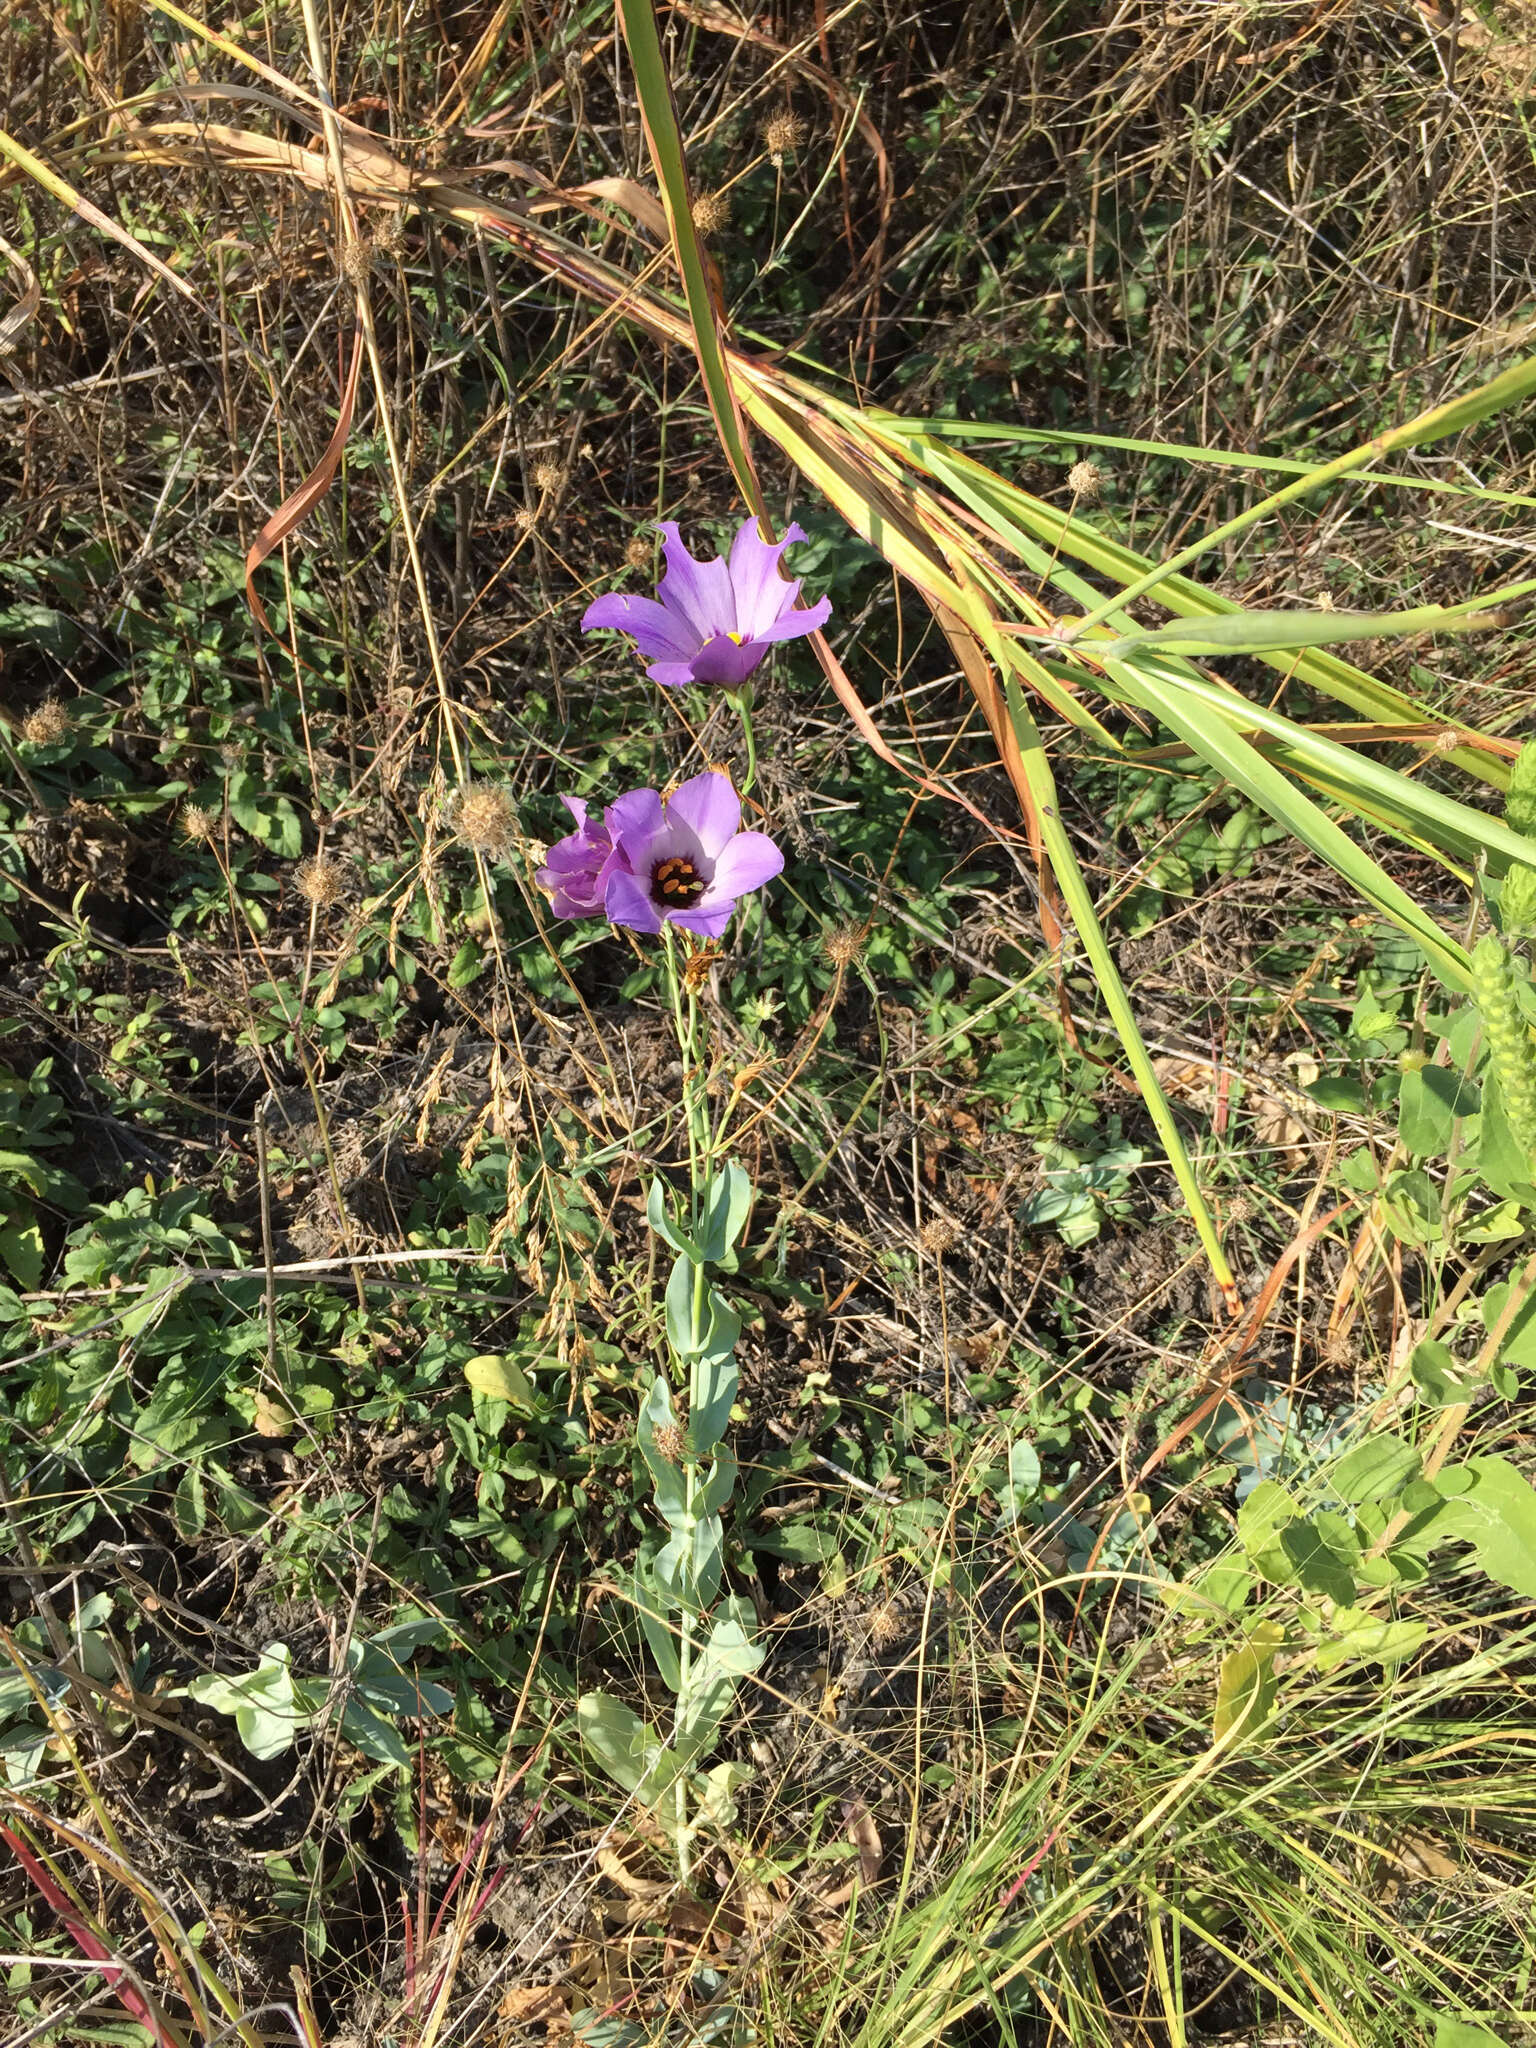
[539,518,811,1872]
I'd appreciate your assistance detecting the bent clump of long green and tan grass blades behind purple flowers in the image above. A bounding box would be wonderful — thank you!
[99,0,1536,1311]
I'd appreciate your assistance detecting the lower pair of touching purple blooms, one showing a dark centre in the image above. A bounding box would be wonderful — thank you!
[539,768,784,938]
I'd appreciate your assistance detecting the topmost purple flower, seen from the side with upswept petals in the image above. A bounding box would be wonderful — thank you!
[582,518,831,688]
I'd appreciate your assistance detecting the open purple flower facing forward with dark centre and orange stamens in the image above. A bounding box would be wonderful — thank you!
[604,770,784,938]
